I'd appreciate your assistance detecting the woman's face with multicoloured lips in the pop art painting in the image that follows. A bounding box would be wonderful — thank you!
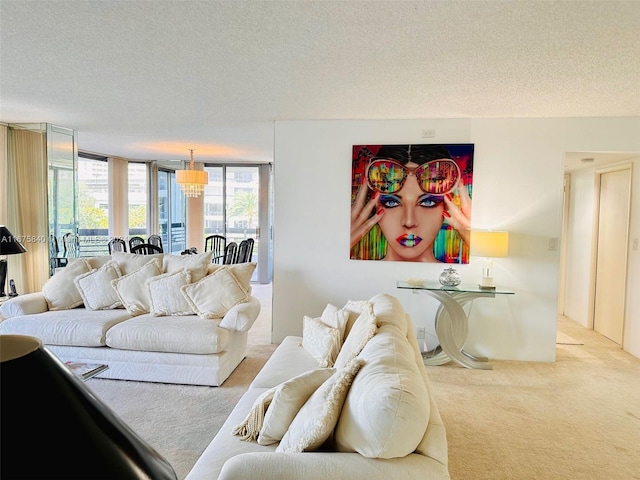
[378,163,444,262]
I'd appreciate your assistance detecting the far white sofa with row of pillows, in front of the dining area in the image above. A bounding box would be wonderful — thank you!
[0,252,260,386]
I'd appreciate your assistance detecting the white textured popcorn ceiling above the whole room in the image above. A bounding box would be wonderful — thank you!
[0,0,640,167]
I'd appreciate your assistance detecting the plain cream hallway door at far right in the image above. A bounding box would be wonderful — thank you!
[593,166,631,345]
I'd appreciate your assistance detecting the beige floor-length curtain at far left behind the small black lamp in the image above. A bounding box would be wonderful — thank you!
[7,128,49,294]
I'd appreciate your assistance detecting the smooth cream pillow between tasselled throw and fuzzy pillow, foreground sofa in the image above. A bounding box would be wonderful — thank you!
[258,368,336,445]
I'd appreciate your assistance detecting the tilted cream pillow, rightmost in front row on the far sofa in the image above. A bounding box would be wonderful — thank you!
[181,266,255,318]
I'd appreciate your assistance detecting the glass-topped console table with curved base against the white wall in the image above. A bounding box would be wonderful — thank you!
[396,281,515,370]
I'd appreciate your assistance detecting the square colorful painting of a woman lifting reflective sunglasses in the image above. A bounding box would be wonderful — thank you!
[350,143,474,263]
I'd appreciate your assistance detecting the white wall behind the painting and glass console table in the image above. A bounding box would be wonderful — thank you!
[273,118,640,361]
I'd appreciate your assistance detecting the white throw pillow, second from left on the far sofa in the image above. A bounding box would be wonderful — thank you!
[73,260,122,310]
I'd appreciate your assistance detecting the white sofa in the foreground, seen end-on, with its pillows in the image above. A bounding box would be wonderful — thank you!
[186,294,450,480]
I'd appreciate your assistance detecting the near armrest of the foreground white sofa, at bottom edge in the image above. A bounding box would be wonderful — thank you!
[218,452,450,480]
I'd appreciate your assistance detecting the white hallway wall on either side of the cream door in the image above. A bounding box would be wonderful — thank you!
[564,157,640,357]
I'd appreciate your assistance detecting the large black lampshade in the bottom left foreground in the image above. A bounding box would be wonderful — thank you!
[0,335,177,480]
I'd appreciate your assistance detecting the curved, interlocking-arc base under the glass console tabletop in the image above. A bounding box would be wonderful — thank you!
[414,290,492,370]
